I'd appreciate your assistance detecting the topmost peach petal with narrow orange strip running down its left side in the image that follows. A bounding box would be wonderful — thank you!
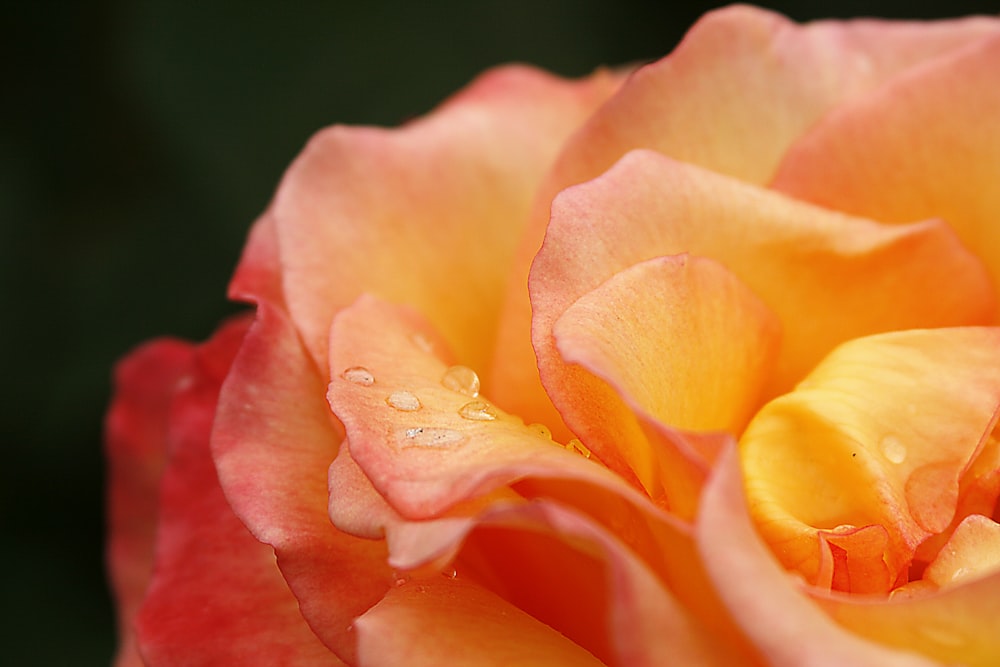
[491,5,1000,434]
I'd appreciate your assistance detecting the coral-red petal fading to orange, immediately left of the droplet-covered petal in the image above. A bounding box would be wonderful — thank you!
[212,304,392,662]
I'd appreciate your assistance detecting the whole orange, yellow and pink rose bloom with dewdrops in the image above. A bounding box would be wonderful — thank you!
[108,7,1000,665]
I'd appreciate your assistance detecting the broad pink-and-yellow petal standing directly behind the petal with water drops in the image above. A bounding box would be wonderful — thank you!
[270,66,619,380]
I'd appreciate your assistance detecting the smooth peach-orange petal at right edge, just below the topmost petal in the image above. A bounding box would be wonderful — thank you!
[773,33,1000,308]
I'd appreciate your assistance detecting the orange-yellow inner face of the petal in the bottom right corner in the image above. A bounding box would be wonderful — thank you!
[810,572,1000,667]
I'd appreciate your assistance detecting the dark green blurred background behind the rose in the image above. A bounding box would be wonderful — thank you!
[0,0,996,666]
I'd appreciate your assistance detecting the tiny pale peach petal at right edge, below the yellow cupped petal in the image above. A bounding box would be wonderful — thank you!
[924,514,1000,586]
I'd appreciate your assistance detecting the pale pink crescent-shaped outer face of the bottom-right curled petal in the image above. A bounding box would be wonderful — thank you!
[695,449,935,667]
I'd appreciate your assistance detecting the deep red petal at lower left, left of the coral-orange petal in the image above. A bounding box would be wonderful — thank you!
[136,320,343,667]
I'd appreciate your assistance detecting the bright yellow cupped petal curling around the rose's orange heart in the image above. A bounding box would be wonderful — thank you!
[740,328,1000,593]
